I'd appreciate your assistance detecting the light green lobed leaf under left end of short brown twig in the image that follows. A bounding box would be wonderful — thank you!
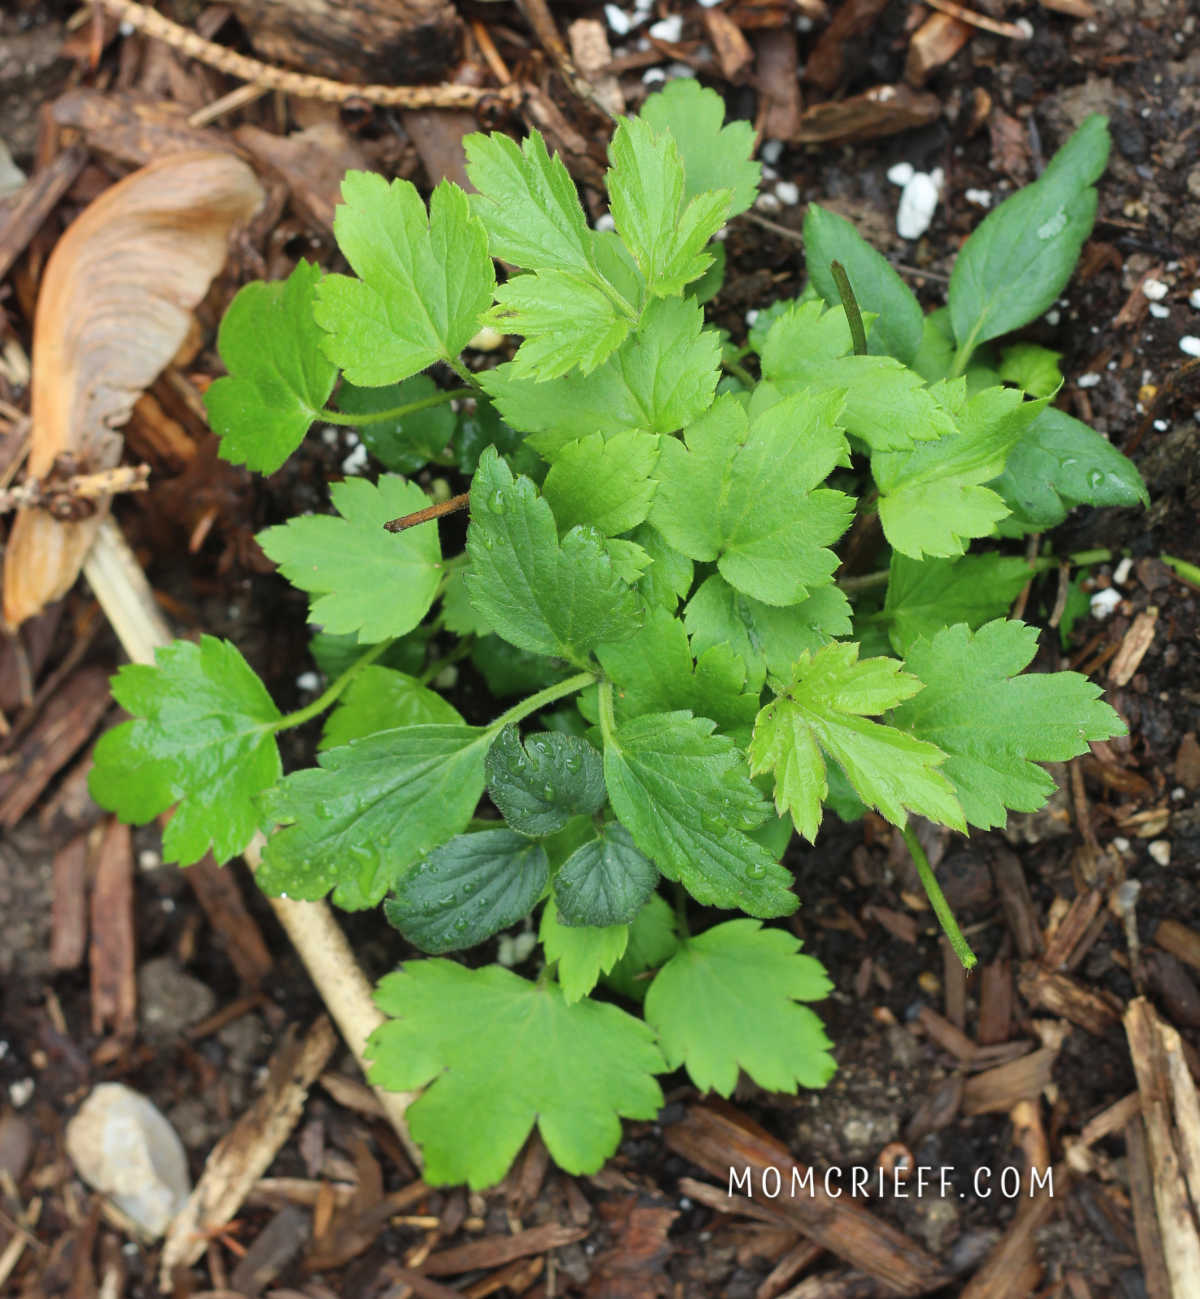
[258,474,442,644]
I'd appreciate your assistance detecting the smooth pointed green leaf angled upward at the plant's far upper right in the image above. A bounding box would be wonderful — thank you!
[949,113,1109,356]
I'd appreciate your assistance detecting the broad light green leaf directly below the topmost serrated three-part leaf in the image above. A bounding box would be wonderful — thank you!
[479,297,721,460]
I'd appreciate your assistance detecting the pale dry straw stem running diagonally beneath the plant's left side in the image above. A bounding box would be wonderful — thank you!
[83,518,422,1169]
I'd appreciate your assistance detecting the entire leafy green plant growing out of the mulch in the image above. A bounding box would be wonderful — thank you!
[92,82,1145,1186]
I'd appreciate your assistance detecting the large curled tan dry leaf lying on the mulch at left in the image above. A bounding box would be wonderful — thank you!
[4,149,262,627]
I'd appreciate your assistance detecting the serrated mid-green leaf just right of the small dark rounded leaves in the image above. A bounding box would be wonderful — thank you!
[604,712,797,916]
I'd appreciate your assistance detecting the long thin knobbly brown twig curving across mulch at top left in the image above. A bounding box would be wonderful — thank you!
[95,0,521,109]
